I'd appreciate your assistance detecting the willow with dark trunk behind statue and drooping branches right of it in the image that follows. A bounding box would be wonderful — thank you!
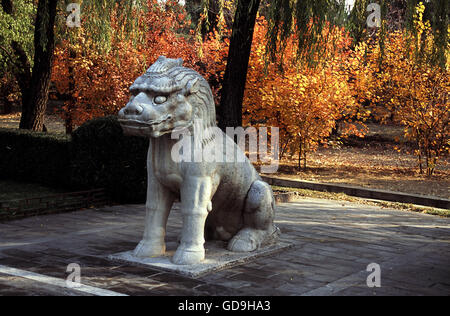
[219,0,344,129]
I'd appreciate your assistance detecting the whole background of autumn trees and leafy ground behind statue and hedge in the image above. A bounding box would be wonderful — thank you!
[0,0,450,198]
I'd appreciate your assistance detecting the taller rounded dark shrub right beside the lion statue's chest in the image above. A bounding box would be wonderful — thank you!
[70,116,148,203]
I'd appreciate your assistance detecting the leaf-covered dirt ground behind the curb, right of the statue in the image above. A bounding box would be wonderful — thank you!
[277,147,450,199]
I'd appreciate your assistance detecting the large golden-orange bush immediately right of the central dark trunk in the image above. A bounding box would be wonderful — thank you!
[244,18,361,167]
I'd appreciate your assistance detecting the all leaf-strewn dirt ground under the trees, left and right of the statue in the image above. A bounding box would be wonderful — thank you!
[0,113,450,198]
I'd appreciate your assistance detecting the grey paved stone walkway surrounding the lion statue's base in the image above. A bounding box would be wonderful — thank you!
[0,199,450,296]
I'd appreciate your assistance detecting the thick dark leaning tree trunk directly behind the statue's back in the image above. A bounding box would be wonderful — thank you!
[219,0,261,131]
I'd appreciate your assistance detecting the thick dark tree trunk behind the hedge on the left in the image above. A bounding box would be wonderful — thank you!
[19,0,58,131]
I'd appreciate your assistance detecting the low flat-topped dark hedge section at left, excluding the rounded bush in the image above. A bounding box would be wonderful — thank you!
[0,128,70,187]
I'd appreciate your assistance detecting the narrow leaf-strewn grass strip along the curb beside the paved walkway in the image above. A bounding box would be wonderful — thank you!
[272,185,450,218]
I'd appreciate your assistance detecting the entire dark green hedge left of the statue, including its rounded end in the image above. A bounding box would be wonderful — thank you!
[0,117,148,203]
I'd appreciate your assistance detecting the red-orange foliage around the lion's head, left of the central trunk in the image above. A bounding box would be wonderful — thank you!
[52,0,228,130]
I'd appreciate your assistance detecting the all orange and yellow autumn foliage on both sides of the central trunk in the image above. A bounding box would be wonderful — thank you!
[52,0,450,175]
